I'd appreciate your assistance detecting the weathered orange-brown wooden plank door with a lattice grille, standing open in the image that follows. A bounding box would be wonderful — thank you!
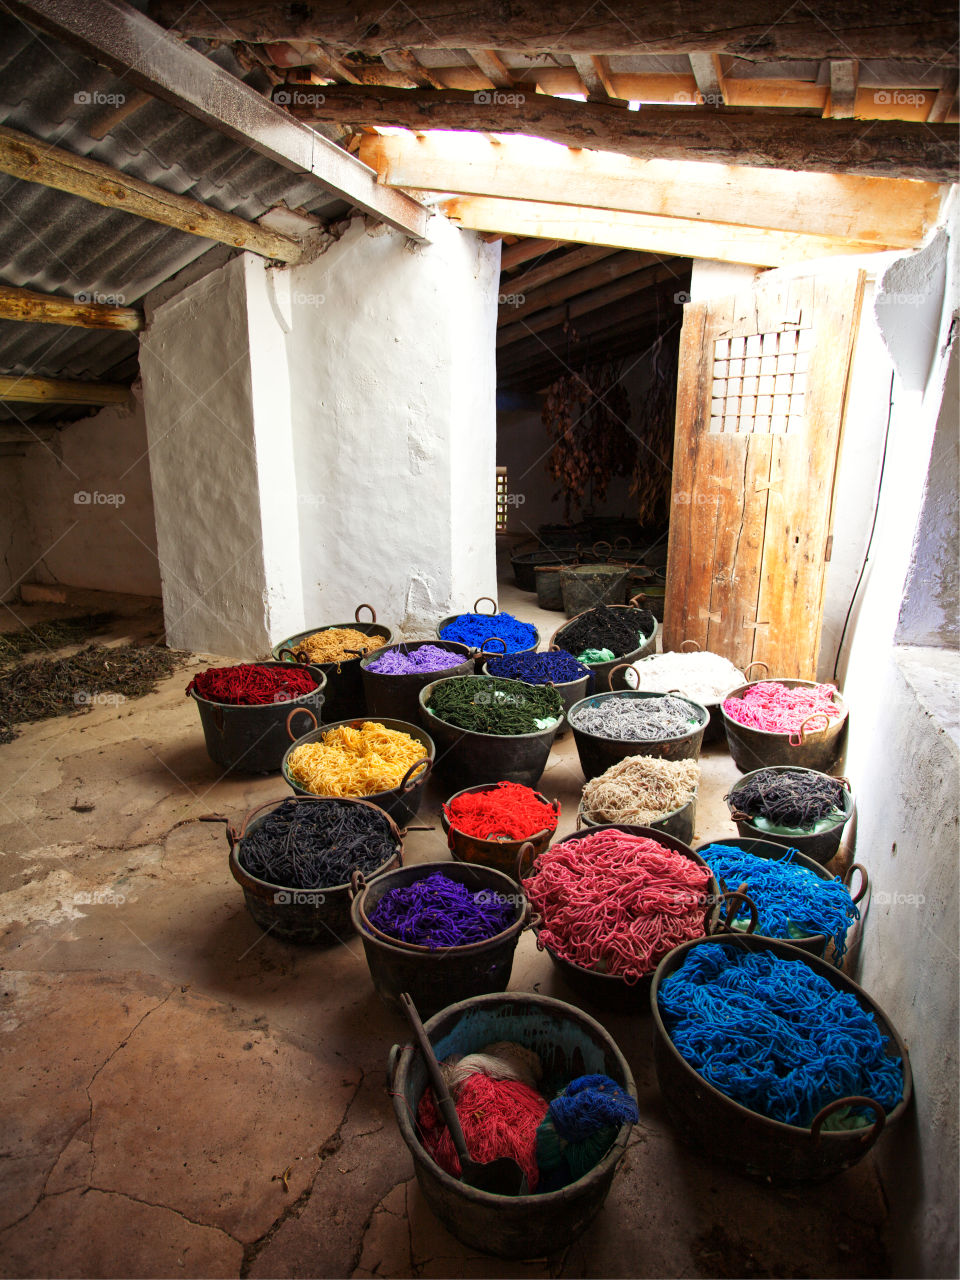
[663,270,864,680]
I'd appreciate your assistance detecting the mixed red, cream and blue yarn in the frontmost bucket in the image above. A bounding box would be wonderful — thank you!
[417,1042,637,1193]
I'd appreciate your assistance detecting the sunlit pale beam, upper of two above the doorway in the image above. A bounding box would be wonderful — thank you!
[360,133,942,248]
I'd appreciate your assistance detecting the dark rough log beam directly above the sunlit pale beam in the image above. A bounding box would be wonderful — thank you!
[292,84,960,182]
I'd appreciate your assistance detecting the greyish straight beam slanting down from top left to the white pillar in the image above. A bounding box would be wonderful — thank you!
[6,0,429,241]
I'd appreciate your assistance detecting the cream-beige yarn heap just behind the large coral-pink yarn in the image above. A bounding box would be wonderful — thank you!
[580,755,700,827]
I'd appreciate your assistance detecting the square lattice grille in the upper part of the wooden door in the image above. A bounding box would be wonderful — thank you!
[710,328,813,435]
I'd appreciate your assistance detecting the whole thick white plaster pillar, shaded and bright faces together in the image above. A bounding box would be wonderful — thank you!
[141,218,499,657]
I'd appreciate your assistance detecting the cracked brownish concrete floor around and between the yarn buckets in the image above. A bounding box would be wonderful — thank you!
[0,586,888,1277]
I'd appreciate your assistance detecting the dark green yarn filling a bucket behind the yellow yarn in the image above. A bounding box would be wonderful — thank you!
[426,676,563,736]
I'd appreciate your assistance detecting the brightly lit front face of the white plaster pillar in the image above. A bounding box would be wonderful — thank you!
[271,218,499,634]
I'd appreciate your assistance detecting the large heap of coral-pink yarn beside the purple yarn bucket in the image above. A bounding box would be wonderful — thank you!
[522,829,710,983]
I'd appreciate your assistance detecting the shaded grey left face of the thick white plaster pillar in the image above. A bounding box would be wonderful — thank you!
[140,257,272,658]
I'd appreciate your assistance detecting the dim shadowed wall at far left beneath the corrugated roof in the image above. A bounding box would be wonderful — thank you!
[3,399,160,595]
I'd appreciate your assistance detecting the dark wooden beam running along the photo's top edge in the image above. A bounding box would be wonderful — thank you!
[150,0,957,60]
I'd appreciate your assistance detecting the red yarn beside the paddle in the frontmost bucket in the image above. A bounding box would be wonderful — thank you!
[417,1071,548,1192]
